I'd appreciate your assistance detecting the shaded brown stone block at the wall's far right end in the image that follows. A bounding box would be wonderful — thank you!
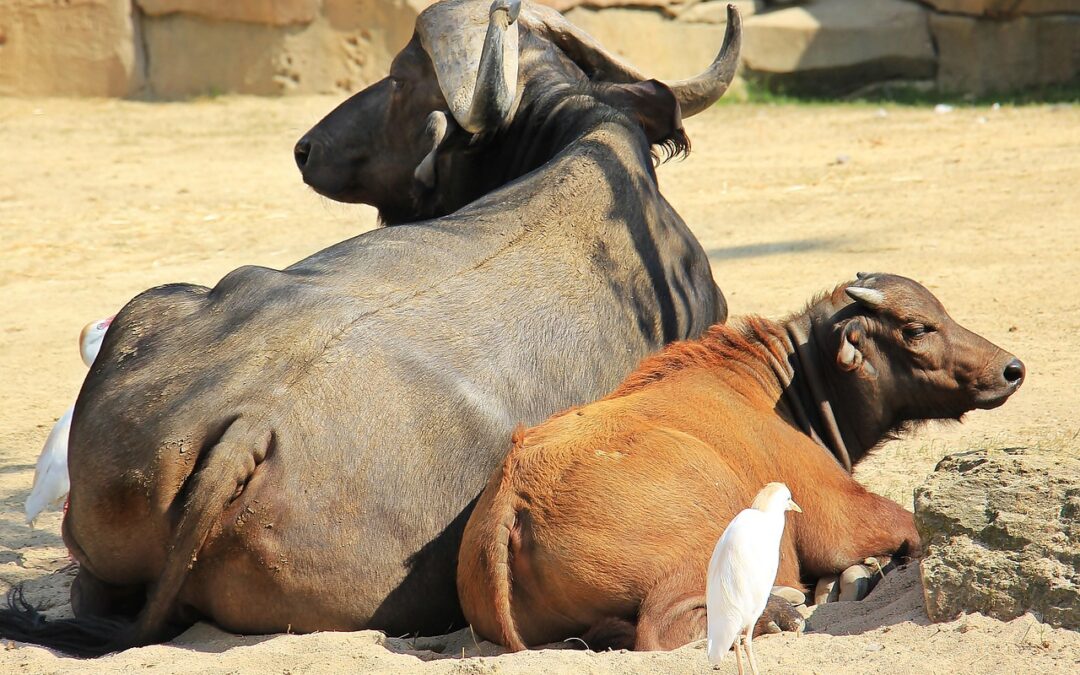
[930,14,1080,94]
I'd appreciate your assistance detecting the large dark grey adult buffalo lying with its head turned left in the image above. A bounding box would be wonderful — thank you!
[0,0,740,656]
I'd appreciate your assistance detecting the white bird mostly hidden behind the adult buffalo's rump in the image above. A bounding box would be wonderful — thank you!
[26,316,112,527]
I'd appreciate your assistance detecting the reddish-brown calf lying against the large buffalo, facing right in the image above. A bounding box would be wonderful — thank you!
[458,274,1024,650]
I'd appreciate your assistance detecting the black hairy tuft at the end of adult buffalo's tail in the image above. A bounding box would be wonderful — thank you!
[0,584,132,659]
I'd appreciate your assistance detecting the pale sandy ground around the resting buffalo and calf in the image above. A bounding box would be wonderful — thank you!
[0,97,1080,674]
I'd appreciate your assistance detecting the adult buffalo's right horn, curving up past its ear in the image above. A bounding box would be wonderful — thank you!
[526,4,742,117]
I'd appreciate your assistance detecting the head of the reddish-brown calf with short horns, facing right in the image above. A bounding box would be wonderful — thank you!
[832,274,1025,436]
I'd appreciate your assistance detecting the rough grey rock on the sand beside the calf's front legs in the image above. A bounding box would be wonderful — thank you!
[915,449,1080,630]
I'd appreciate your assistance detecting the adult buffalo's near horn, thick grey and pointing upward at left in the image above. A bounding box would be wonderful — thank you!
[417,0,522,134]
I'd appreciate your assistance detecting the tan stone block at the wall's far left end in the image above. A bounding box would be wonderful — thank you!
[0,0,145,96]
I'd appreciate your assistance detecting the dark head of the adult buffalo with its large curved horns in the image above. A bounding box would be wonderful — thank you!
[295,0,740,222]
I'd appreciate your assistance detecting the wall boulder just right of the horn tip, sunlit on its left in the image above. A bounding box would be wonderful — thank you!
[743,0,936,94]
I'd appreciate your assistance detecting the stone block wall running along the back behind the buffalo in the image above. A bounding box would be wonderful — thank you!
[0,0,1080,98]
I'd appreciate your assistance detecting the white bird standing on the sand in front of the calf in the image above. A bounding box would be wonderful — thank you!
[705,483,802,675]
